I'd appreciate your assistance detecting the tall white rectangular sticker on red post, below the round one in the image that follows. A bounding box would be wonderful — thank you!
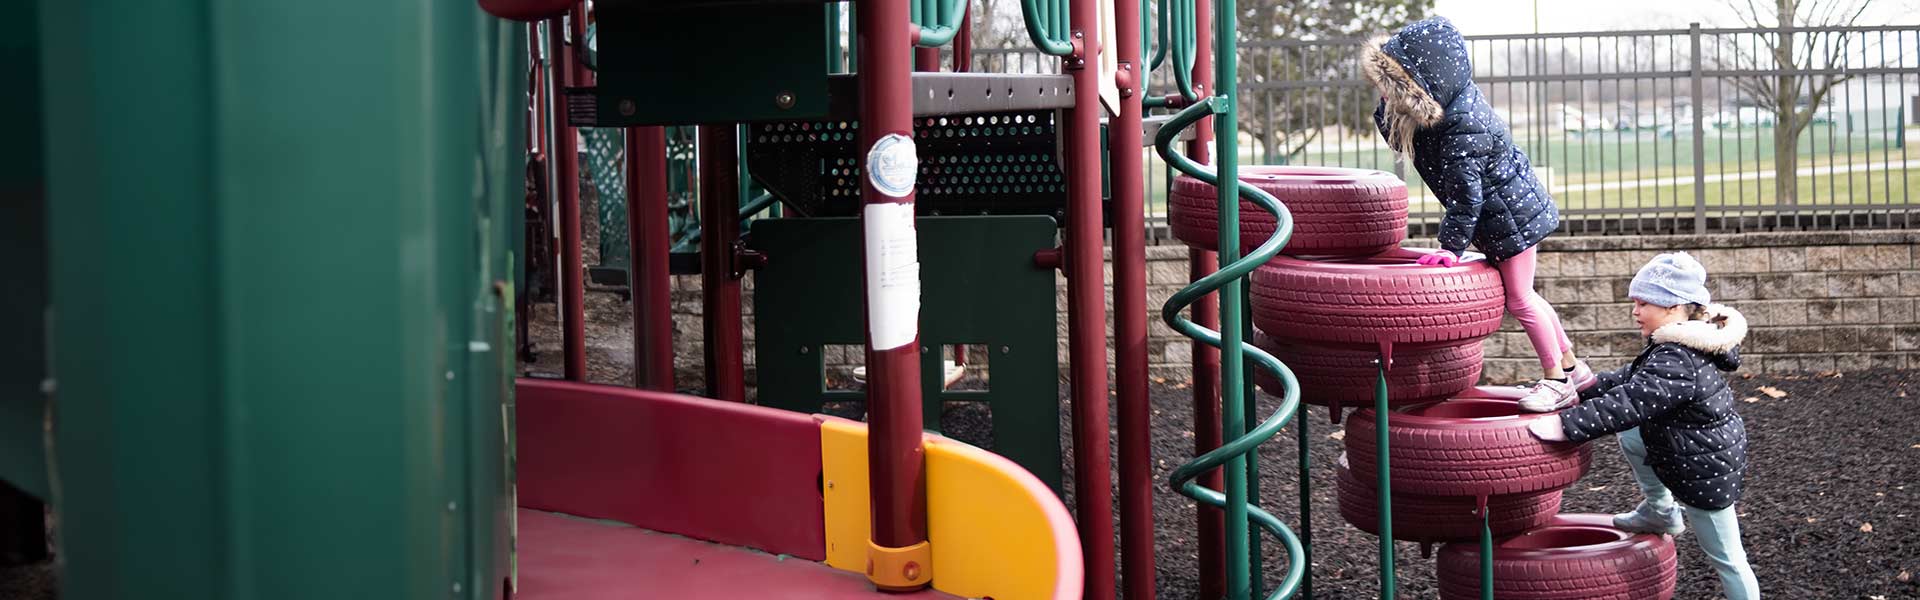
[862,202,920,350]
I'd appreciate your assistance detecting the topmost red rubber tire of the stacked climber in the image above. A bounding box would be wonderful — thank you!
[1167,167,1407,256]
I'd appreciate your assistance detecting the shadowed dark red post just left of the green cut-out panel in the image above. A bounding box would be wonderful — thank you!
[699,123,747,402]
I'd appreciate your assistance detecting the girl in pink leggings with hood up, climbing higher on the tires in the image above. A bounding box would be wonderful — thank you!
[1361,17,1594,412]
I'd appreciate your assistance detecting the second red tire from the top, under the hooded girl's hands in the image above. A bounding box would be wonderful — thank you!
[1252,248,1507,348]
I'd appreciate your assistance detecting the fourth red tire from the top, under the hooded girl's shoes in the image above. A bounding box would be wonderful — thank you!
[1346,394,1592,496]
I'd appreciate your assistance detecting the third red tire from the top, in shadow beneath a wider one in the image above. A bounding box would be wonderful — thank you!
[1254,331,1484,408]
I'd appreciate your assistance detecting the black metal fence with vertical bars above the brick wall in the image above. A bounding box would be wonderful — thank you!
[975,25,1920,241]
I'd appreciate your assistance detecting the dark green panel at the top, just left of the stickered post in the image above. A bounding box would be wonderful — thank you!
[593,2,828,127]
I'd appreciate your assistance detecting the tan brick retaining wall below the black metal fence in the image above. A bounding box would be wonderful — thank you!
[674,231,1920,385]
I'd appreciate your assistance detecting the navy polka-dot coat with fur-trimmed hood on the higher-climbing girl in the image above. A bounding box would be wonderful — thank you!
[1361,17,1559,262]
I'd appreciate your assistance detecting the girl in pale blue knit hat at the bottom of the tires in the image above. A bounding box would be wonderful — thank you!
[1528,252,1761,600]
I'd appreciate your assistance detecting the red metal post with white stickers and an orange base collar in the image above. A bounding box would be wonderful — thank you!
[854,0,933,590]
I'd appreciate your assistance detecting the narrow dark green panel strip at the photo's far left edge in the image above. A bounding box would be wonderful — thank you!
[0,2,48,500]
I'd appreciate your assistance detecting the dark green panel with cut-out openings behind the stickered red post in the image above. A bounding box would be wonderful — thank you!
[747,215,1062,492]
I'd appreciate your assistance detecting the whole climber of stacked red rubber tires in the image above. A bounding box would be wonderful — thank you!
[1167,167,1676,600]
